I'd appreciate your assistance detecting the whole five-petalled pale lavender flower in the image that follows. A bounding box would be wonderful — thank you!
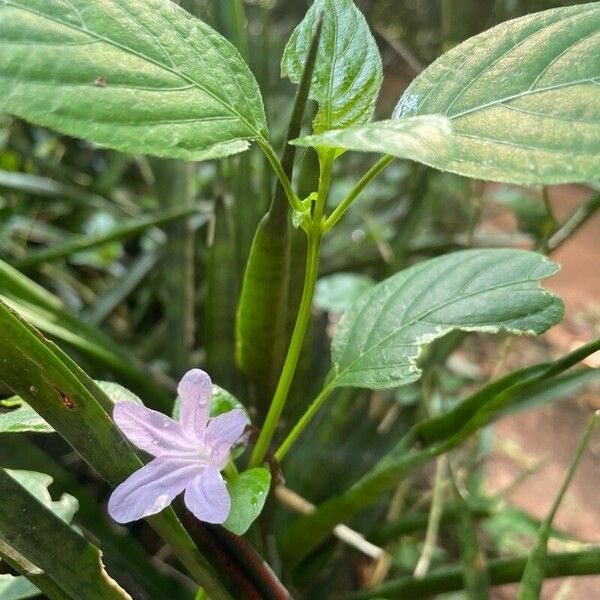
[108,369,247,523]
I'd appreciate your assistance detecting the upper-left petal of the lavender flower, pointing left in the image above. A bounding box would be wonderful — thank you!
[113,401,191,456]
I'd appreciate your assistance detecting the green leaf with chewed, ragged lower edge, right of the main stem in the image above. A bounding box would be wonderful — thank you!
[328,249,563,389]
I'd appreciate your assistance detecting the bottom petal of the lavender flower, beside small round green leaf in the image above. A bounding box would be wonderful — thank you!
[184,465,231,523]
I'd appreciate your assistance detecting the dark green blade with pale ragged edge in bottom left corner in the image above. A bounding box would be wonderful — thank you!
[0,469,130,600]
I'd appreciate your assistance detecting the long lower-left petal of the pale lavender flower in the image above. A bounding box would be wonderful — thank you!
[108,457,202,523]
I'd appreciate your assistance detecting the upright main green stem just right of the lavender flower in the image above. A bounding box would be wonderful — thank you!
[249,229,321,468]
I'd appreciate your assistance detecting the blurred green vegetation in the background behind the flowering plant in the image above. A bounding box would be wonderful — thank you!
[0,0,600,598]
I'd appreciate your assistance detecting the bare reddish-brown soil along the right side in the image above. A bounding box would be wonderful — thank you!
[486,186,600,600]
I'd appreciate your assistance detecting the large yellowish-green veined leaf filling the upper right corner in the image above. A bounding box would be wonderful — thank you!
[394,2,600,184]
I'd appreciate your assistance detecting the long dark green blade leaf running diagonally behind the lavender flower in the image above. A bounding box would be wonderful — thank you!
[0,300,230,599]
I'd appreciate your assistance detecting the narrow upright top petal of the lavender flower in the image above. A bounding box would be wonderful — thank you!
[177,369,212,440]
